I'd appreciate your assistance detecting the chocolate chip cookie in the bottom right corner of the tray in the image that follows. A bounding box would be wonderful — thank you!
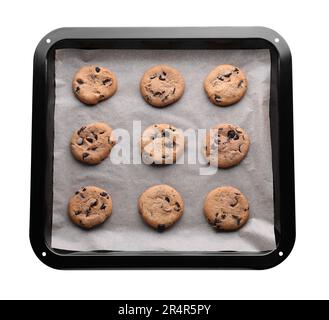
[204,187,249,231]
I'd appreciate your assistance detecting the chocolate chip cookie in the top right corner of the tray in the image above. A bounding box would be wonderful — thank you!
[204,64,248,107]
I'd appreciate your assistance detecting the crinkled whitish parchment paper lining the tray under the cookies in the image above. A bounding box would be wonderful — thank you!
[52,49,275,251]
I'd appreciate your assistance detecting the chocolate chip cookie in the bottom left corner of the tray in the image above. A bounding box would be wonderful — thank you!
[68,186,112,229]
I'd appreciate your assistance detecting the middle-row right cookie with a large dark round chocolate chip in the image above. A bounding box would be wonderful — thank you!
[203,124,250,168]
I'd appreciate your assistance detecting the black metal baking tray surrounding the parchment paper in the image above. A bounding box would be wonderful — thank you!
[30,27,295,269]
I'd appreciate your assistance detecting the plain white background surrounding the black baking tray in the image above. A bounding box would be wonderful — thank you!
[0,0,329,299]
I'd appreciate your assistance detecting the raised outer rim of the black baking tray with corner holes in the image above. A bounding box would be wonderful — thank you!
[30,27,295,269]
